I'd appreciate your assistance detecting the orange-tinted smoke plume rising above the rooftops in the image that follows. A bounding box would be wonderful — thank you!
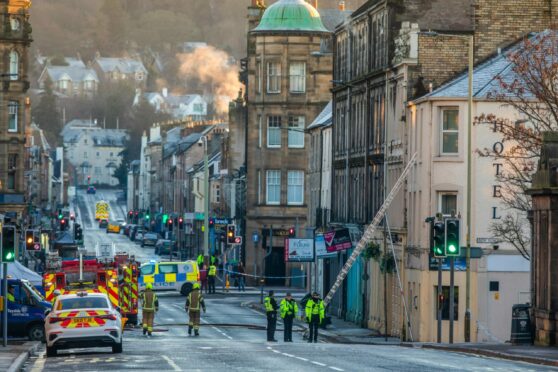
[177,46,243,115]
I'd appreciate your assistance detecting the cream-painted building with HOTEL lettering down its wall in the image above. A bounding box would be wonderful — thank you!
[405,40,530,342]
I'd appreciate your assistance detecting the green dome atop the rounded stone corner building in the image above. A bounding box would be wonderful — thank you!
[254,0,329,32]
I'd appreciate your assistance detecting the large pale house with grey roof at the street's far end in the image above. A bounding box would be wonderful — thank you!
[61,119,129,186]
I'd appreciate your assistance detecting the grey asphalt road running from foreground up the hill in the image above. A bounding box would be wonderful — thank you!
[24,190,555,372]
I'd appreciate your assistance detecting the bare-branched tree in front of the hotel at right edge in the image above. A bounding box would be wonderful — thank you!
[475,31,558,259]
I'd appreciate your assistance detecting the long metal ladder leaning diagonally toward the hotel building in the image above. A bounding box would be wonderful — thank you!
[324,153,417,312]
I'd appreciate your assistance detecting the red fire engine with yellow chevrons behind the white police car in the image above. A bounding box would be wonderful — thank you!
[43,253,139,325]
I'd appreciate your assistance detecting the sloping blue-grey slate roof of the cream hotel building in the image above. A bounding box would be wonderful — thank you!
[417,31,558,101]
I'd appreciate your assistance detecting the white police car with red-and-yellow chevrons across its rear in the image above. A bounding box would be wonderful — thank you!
[45,292,122,357]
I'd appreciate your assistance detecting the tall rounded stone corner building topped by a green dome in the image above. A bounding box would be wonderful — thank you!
[245,0,344,284]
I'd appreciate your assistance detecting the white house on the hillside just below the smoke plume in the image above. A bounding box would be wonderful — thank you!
[134,88,207,120]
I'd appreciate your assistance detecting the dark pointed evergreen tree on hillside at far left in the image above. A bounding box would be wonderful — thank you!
[32,78,62,146]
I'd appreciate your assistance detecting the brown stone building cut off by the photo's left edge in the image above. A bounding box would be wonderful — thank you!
[0,0,32,217]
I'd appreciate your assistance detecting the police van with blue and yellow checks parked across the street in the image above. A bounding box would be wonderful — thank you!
[138,261,200,296]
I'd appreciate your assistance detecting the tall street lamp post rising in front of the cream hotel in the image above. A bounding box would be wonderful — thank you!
[422,32,475,342]
